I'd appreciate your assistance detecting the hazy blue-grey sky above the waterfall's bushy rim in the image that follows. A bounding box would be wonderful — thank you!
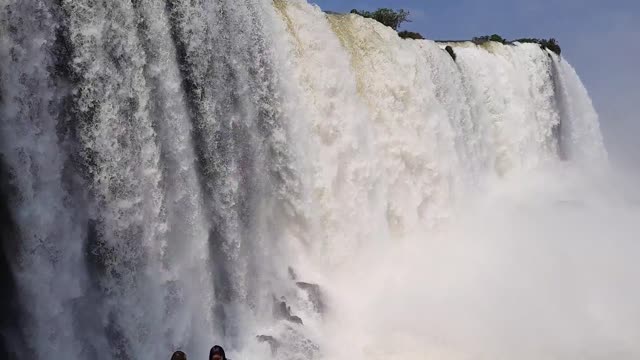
[310,0,640,168]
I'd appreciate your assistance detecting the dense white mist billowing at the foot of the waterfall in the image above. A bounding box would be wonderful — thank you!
[327,167,640,359]
